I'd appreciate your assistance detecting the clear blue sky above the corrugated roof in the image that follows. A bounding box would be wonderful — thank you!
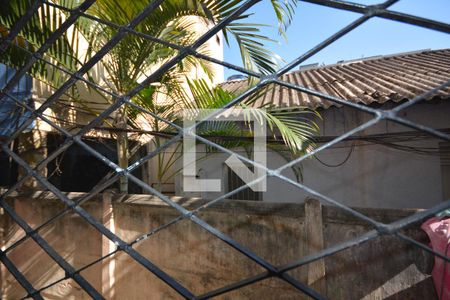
[224,0,450,78]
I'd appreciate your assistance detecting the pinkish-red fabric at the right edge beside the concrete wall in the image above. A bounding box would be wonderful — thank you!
[421,218,450,300]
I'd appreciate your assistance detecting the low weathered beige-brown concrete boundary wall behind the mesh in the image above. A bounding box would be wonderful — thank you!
[2,193,435,300]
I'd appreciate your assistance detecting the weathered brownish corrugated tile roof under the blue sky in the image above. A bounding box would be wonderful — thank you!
[221,49,450,108]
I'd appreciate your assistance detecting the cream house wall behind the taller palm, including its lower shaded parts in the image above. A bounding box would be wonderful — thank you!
[0,11,223,189]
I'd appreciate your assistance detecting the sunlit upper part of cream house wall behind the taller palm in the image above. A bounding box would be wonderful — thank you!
[29,16,224,134]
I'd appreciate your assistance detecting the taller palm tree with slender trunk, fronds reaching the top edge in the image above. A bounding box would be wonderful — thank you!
[0,0,314,192]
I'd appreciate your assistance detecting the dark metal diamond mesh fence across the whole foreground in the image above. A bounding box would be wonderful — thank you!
[0,0,450,299]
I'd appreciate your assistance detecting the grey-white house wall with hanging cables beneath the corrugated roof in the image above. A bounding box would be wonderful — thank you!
[176,101,450,208]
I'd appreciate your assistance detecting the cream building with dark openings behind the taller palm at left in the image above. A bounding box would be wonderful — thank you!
[0,16,223,193]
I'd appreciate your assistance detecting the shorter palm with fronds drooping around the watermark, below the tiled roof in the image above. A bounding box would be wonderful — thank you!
[140,79,320,188]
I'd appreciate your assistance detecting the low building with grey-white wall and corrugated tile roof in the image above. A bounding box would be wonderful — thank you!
[175,49,450,208]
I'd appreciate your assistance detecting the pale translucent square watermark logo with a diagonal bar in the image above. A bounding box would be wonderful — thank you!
[183,108,267,192]
